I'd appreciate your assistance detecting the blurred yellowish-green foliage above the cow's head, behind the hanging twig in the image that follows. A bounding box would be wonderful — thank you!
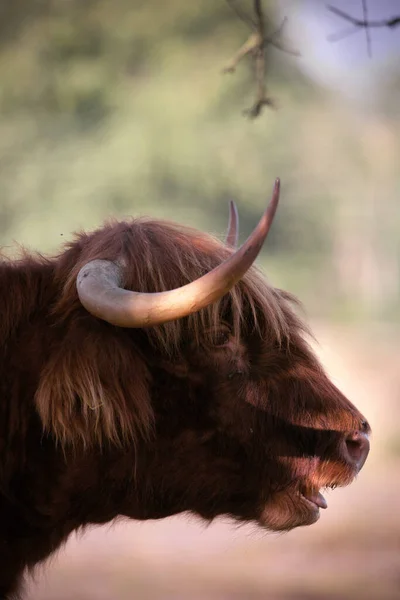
[0,0,400,319]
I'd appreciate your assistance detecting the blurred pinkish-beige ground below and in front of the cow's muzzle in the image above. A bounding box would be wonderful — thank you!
[27,324,400,600]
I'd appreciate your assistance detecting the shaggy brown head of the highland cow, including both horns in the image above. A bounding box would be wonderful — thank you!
[38,181,370,530]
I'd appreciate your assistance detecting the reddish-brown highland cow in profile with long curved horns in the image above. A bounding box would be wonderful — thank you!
[0,180,370,598]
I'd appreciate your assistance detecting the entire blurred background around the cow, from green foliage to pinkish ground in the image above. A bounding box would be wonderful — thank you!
[0,0,400,600]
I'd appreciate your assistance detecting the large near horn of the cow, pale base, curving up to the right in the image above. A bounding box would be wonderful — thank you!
[77,179,280,327]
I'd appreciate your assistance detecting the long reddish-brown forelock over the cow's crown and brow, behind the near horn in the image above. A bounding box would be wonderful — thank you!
[56,218,305,355]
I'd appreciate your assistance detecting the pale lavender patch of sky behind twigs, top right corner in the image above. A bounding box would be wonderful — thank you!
[276,0,400,101]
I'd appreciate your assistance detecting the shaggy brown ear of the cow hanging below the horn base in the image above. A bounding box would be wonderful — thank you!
[35,318,154,446]
